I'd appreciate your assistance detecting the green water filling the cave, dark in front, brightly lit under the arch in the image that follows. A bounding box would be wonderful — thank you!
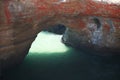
[3,32,120,80]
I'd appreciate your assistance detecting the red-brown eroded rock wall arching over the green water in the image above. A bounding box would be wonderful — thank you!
[0,0,120,72]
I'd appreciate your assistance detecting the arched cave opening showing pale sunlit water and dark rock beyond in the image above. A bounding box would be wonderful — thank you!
[29,24,68,54]
